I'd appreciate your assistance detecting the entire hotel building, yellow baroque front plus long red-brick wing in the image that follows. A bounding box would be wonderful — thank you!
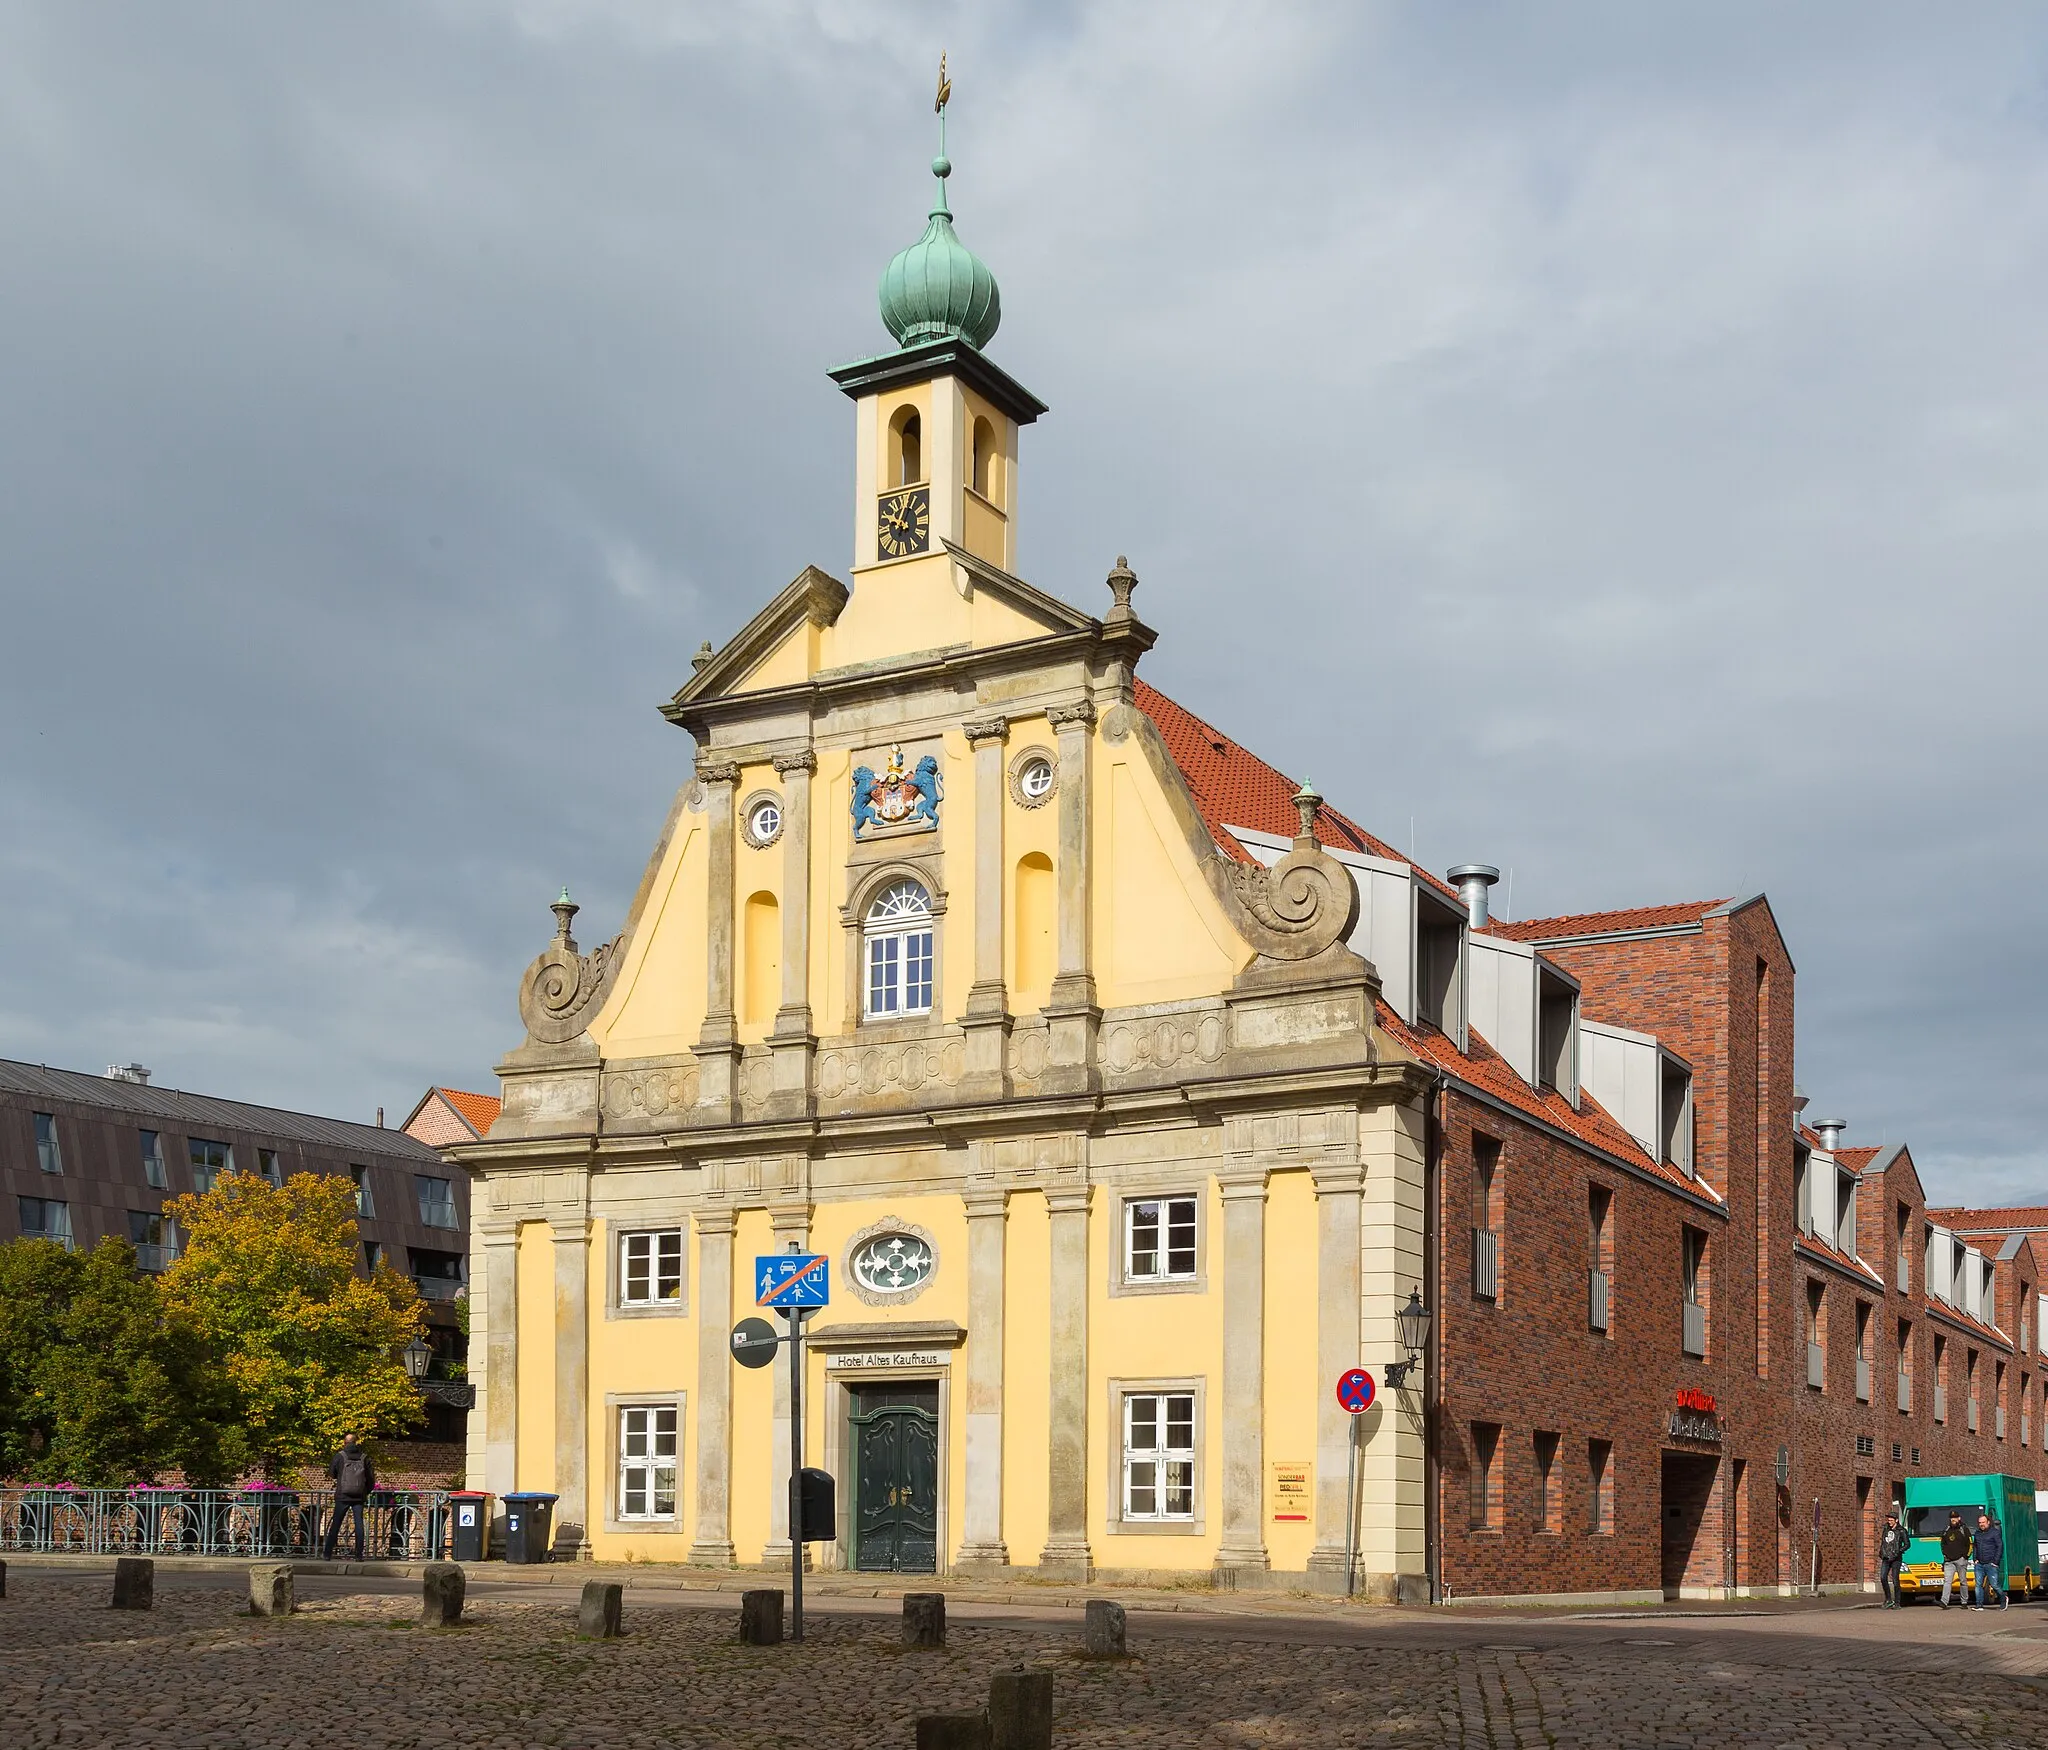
[451,95,2044,1600]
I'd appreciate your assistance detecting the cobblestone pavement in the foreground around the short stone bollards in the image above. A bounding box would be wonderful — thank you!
[0,1564,2048,1750]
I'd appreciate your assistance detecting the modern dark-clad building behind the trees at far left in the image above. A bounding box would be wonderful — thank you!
[0,1059,469,1441]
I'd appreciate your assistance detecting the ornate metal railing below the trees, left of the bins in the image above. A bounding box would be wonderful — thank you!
[0,1484,451,1561]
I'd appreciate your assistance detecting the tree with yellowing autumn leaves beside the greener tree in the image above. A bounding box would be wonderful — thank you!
[164,1172,424,1475]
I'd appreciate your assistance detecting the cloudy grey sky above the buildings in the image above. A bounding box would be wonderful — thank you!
[0,0,2048,1201]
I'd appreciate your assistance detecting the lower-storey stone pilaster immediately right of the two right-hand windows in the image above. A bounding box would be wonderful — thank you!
[1217,1172,1272,1580]
